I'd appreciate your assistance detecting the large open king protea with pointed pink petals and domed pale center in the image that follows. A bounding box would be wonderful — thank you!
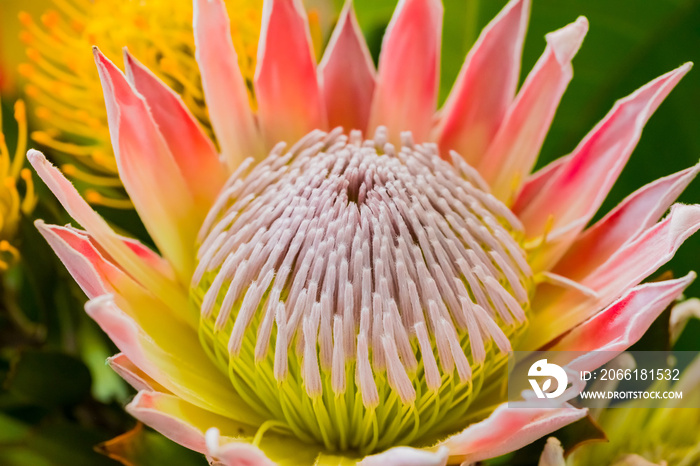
[28,0,700,465]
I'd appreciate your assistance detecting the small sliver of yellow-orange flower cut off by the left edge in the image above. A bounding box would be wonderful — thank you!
[0,101,36,271]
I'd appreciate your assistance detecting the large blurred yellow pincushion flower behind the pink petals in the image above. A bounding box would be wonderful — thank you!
[19,0,262,207]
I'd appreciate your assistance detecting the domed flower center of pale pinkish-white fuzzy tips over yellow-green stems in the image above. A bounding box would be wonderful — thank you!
[191,129,532,454]
